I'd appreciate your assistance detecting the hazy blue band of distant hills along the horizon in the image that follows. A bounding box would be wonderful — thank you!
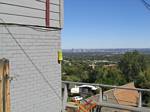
[63,48,150,54]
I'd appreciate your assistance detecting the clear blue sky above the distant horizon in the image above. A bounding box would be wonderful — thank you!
[62,0,150,49]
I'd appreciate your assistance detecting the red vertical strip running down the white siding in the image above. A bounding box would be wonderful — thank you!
[45,0,50,27]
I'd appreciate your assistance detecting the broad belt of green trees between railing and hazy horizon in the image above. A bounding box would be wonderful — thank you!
[62,51,150,106]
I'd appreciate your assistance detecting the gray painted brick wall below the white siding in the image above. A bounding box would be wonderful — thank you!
[0,26,61,112]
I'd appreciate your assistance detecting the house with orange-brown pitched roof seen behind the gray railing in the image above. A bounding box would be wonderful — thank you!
[102,83,139,112]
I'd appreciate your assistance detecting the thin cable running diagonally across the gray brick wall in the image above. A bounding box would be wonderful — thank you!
[0,18,62,101]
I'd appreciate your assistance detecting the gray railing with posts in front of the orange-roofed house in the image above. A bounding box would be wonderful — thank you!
[62,81,150,112]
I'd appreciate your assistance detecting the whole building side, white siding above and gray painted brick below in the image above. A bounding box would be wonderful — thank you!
[0,0,63,112]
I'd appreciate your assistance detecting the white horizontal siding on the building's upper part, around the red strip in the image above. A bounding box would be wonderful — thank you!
[0,0,63,28]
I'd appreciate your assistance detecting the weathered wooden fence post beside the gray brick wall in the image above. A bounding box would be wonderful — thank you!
[0,59,10,112]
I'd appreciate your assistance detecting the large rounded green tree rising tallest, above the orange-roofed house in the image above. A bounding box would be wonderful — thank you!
[119,51,146,82]
